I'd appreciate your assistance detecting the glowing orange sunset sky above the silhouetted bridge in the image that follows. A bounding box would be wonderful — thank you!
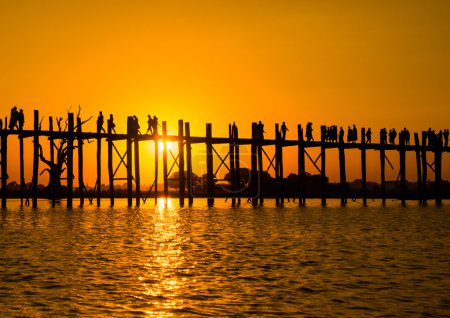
[0,0,450,184]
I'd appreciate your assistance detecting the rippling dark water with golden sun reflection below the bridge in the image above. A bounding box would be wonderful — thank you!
[0,200,450,317]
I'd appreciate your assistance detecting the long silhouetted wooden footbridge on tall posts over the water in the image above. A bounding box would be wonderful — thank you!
[0,110,450,208]
